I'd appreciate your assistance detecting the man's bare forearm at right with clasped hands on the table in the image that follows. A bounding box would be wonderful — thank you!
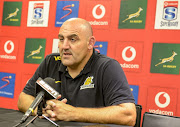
[46,100,136,126]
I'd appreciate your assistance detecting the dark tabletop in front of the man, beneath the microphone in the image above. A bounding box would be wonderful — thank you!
[0,108,130,127]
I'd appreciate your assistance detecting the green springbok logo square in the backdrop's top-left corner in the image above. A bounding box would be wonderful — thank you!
[2,1,22,26]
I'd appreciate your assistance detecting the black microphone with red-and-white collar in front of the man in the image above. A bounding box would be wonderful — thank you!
[21,77,59,123]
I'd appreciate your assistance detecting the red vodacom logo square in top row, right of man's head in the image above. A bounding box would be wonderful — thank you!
[86,1,112,29]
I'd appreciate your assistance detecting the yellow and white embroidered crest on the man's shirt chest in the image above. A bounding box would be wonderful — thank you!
[80,76,94,90]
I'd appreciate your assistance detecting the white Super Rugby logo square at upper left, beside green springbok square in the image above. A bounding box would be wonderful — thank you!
[27,1,50,27]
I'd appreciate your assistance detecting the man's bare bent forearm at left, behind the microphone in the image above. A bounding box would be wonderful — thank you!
[18,92,37,115]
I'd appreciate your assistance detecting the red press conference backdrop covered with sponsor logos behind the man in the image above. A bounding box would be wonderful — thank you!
[0,0,180,119]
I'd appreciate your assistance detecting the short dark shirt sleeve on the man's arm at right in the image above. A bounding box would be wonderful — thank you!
[103,59,135,106]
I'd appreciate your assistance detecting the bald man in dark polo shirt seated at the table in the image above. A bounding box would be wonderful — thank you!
[18,18,136,126]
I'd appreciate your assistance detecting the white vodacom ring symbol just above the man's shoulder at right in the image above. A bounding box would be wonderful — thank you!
[122,46,136,62]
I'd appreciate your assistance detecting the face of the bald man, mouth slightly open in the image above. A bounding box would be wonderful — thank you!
[59,21,89,67]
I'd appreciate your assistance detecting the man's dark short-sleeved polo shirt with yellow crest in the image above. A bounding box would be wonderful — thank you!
[23,52,134,107]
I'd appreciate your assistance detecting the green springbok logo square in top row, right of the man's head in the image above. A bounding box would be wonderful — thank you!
[118,0,147,29]
